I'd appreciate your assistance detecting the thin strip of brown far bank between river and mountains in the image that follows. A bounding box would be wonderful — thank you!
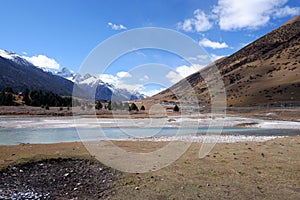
[0,106,300,121]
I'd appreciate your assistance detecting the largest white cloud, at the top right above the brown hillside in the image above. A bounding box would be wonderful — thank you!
[213,0,299,31]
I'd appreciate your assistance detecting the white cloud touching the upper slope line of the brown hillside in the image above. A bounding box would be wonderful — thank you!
[166,65,203,84]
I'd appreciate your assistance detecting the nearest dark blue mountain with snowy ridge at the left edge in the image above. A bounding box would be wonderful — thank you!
[0,50,77,96]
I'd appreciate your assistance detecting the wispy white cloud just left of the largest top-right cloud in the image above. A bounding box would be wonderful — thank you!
[178,9,212,32]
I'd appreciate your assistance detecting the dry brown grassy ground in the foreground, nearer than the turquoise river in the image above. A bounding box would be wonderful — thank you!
[0,136,300,199]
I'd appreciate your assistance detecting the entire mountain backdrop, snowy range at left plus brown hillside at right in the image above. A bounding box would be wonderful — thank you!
[0,16,300,106]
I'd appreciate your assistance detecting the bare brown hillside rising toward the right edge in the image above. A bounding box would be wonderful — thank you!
[151,16,300,106]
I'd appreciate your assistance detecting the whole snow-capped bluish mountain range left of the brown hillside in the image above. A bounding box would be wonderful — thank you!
[0,50,146,101]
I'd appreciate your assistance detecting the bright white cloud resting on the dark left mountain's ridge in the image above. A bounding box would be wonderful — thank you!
[22,55,60,69]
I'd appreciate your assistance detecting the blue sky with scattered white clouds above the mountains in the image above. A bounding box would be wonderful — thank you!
[0,0,300,95]
